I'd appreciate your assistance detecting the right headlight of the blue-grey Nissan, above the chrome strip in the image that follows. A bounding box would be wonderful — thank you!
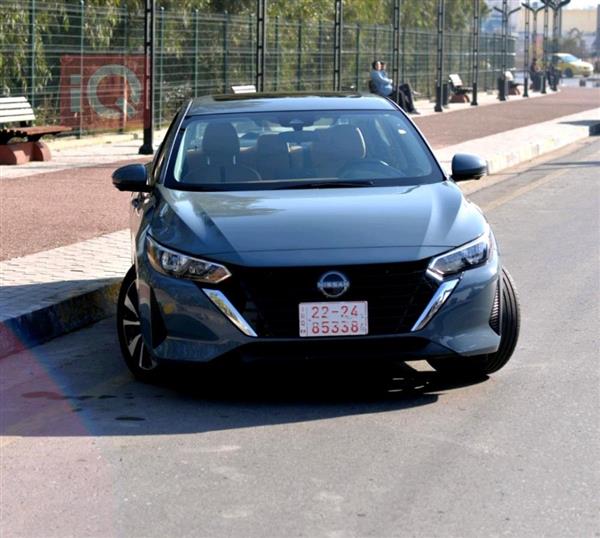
[427,228,494,280]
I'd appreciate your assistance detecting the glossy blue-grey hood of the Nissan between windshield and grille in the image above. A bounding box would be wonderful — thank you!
[150,181,485,266]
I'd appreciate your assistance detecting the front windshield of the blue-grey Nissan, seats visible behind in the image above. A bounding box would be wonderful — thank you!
[166,110,443,191]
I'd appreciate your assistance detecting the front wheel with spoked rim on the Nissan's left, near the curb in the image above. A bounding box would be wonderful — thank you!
[117,266,162,383]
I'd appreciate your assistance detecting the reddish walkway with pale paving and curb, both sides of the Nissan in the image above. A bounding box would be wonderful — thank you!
[0,89,600,356]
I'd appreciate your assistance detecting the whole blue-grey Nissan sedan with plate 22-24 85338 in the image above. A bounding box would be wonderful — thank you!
[113,93,520,380]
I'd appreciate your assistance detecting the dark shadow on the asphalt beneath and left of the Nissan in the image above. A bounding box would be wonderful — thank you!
[0,331,484,437]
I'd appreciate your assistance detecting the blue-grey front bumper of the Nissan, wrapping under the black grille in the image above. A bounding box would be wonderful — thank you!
[136,247,500,363]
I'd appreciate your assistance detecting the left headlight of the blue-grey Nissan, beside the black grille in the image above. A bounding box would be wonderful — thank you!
[146,237,231,284]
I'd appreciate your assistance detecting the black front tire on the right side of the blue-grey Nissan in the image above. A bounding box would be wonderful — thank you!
[427,269,521,377]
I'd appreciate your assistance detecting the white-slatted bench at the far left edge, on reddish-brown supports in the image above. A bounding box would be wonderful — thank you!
[0,97,71,164]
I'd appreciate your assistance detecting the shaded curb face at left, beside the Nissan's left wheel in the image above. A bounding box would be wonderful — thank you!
[0,279,121,358]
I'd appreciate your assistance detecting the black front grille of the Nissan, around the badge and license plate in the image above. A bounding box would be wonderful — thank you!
[222,260,435,338]
